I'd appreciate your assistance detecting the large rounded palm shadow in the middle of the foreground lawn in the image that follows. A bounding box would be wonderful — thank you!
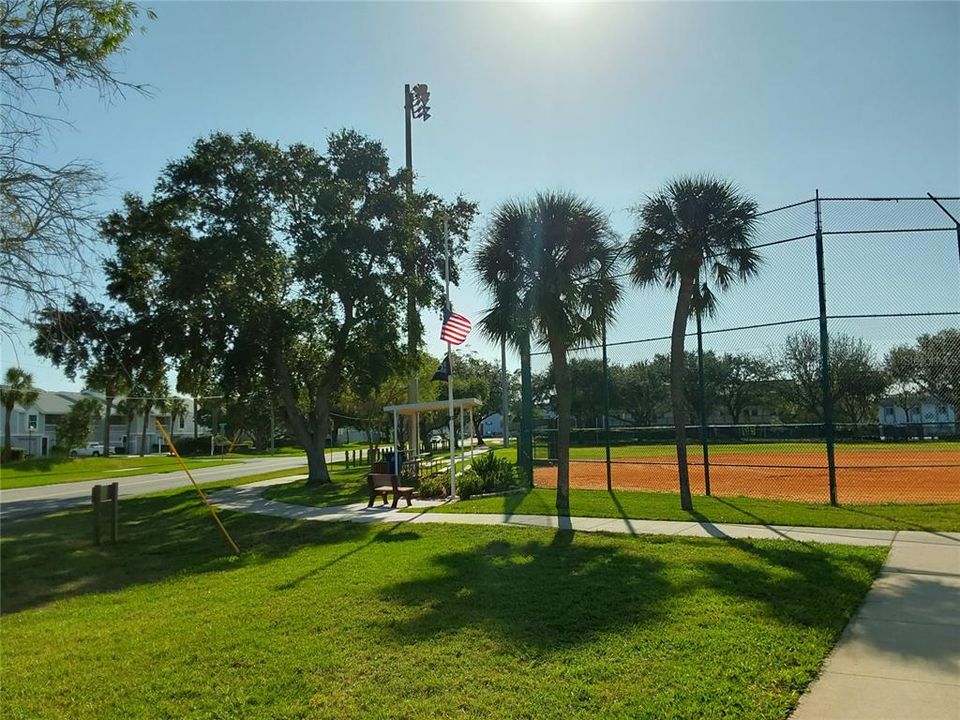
[381,530,671,650]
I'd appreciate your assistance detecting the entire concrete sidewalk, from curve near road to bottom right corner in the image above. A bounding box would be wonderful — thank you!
[211,478,960,720]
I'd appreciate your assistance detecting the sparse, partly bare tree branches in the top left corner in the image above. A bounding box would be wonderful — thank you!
[0,0,153,332]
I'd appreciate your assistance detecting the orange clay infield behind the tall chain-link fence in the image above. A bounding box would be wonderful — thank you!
[533,446,960,504]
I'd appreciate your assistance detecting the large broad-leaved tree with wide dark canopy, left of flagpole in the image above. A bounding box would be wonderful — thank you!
[103,130,476,482]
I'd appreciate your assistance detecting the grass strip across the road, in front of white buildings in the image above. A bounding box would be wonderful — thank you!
[0,455,244,490]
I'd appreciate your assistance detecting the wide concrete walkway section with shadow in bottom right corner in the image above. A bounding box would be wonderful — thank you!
[791,532,960,720]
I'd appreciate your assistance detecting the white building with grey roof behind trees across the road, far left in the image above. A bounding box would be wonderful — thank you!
[0,390,209,456]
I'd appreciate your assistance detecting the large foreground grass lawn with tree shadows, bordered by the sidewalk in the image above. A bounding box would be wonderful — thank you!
[0,476,885,720]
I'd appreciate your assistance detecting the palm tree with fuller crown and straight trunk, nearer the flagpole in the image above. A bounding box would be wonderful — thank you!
[474,192,621,513]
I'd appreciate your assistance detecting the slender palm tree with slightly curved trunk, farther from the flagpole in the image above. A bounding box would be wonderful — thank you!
[627,176,760,510]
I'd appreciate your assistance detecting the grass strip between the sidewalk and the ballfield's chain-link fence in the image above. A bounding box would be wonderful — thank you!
[430,488,960,531]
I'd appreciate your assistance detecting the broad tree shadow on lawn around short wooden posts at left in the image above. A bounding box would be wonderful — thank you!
[0,488,371,614]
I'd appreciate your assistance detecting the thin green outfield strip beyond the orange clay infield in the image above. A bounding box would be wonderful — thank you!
[552,441,960,463]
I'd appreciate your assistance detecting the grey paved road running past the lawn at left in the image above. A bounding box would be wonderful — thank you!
[0,453,314,520]
